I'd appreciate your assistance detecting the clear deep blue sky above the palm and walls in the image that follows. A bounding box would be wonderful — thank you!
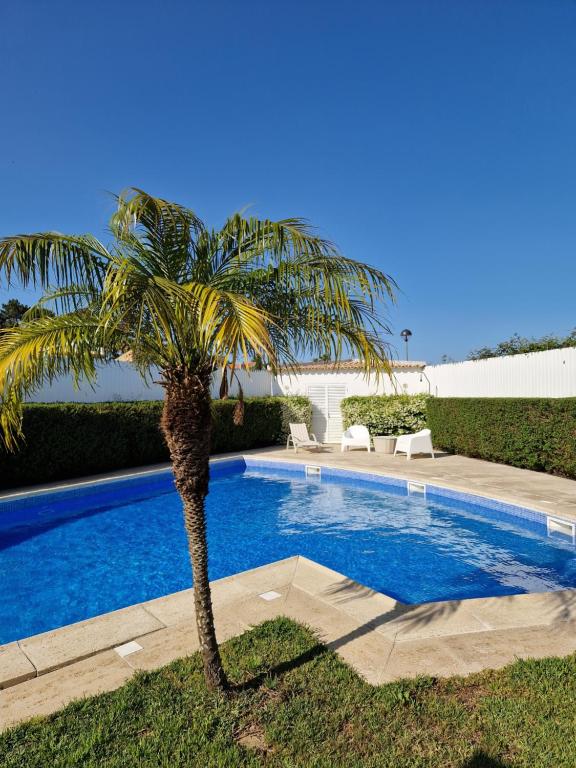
[0,0,576,362]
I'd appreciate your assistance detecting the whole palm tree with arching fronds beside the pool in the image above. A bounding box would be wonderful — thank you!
[0,189,395,690]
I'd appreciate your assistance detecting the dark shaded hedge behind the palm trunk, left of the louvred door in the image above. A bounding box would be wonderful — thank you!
[0,397,312,488]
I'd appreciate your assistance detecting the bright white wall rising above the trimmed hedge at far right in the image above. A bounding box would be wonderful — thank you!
[425,347,576,397]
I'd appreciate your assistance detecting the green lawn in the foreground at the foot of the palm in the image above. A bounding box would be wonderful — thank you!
[0,619,576,768]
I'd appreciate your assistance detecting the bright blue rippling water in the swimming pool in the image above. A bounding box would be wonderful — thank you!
[0,461,576,643]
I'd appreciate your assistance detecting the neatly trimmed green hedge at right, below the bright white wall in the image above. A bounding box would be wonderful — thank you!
[427,397,576,478]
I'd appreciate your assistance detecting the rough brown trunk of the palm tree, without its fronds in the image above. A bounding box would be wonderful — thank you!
[161,367,228,691]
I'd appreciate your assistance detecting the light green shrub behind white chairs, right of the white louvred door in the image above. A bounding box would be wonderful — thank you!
[341,395,429,437]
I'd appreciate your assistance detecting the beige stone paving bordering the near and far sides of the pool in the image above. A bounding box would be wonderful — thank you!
[0,449,576,728]
